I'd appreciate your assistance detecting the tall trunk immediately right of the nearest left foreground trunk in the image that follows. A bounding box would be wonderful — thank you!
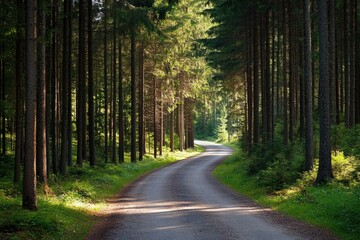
[36,0,48,188]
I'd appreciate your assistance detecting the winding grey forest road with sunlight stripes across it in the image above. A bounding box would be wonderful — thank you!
[87,141,336,240]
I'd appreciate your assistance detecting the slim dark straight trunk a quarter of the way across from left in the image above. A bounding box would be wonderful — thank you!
[87,0,96,166]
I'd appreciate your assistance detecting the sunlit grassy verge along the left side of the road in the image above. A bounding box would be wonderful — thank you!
[0,147,203,239]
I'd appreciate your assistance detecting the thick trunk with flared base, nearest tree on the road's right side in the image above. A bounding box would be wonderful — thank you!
[316,0,333,183]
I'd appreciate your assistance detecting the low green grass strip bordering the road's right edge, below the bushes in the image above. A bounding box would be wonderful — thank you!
[213,145,360,240]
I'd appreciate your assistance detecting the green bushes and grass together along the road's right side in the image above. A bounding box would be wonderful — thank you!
[213,131,360,240]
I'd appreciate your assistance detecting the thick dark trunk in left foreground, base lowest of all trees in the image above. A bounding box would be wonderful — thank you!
[22,0,37,210]
